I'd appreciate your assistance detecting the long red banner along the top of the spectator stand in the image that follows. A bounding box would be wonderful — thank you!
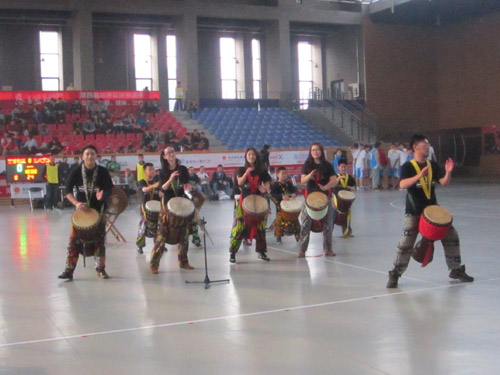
[0,90,160,101]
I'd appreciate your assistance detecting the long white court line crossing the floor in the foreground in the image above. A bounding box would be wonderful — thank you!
[0,277,500,348]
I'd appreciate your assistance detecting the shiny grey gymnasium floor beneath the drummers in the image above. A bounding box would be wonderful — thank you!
[0,183,500,375]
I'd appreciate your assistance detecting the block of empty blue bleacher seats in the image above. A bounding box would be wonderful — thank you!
[193,107,340,150]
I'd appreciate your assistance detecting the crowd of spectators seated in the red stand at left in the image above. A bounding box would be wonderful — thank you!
[0,98,209,156]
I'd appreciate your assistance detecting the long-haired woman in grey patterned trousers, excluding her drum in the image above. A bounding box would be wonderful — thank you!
[298,142,338,258]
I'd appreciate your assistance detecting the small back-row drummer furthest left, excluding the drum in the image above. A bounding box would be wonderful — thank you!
[135,163,160,254]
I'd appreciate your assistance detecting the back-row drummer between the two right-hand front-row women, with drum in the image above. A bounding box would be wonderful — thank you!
[271,167,303,244]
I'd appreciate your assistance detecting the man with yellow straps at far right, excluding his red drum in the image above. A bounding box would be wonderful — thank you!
[387,134,474,288]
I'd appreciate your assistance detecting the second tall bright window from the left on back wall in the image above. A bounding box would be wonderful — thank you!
[134,34,153,91]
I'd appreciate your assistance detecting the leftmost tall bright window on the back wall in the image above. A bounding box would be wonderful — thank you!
[40,31,62,91]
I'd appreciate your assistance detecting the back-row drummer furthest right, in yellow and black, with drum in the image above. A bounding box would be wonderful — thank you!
[333,159,356,238]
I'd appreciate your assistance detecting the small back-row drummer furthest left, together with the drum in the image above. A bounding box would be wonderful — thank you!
[135,163,161,254]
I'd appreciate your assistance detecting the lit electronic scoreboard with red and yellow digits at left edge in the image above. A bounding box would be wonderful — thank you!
[5,156,51,184]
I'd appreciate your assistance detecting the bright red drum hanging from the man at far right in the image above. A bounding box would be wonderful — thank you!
[412,205,453,267]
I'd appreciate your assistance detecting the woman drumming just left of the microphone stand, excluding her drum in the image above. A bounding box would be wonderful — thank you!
[149,145,193,274]
